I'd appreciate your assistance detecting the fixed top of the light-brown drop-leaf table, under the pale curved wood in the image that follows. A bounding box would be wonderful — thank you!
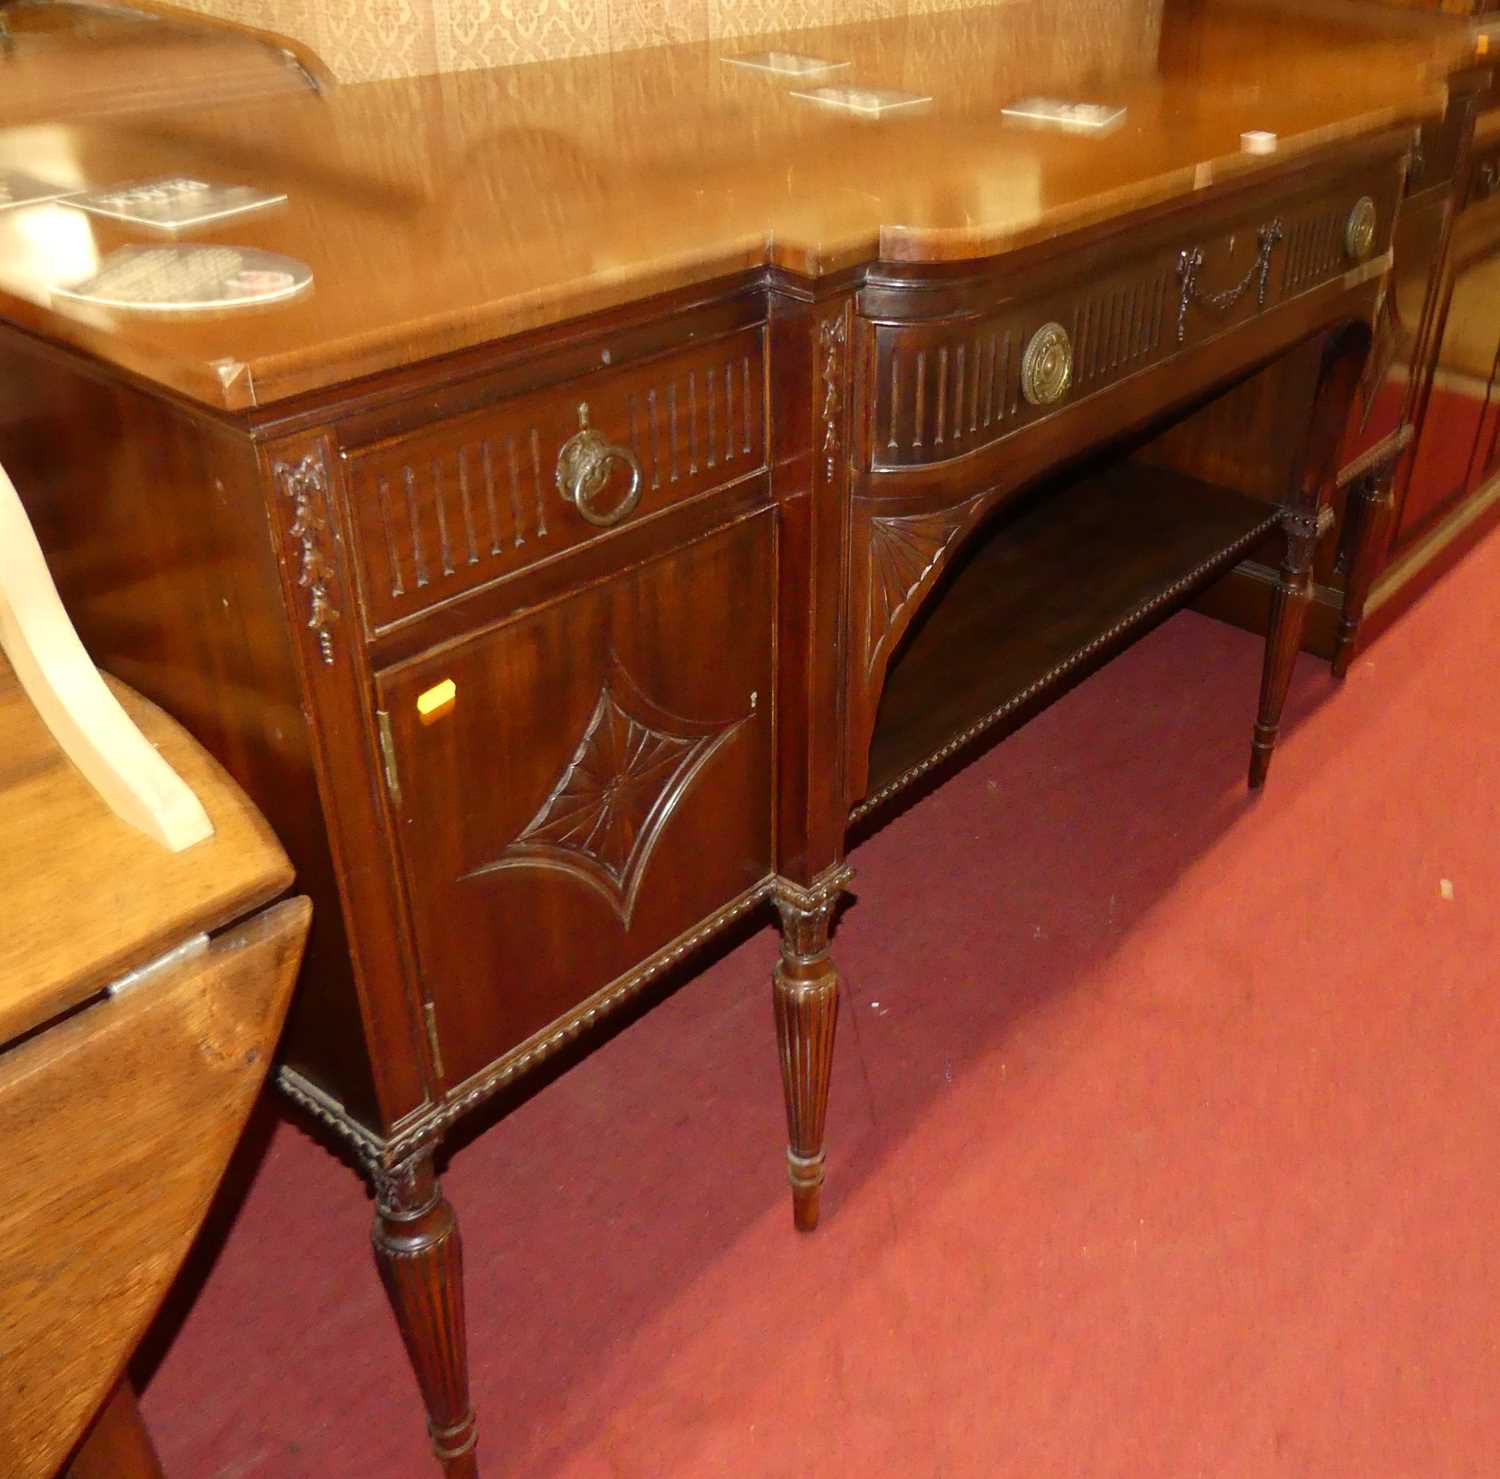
[0,660,293,1041]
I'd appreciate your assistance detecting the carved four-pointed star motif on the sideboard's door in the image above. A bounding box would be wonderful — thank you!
[462,659,749,929]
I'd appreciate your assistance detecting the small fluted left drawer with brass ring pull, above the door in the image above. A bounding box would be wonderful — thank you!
[344,326,765,629]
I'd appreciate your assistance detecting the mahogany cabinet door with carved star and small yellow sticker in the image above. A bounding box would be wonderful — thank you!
[378,513,774,1085]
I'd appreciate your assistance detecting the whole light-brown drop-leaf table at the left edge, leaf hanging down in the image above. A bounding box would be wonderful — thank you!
[0,659,311,1479]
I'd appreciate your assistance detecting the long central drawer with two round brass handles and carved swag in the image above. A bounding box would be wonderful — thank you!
[860,164,1401,473]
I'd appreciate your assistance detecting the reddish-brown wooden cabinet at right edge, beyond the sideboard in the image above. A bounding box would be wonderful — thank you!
[1197,0,1500,660]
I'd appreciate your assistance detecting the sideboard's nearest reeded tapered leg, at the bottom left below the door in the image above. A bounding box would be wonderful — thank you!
[372,1148,479,1479]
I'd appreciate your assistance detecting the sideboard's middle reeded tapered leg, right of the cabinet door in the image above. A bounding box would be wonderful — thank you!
[771,867,852,1233]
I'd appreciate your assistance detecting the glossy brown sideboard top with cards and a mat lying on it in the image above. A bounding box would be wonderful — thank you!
[0,0,1463,411]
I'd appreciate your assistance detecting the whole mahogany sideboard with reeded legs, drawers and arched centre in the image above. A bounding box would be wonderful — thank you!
[0,0,1455,1475]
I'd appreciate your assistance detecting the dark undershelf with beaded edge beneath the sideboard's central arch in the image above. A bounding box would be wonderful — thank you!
[854,462,1278,821]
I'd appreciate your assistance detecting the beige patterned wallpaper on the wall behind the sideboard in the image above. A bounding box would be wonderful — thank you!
[180,0,1161,83]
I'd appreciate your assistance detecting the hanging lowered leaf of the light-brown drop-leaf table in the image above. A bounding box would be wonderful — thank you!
[0,899,309,1479]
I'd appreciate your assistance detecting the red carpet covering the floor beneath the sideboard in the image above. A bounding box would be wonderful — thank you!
[144,537,1500,1479]
